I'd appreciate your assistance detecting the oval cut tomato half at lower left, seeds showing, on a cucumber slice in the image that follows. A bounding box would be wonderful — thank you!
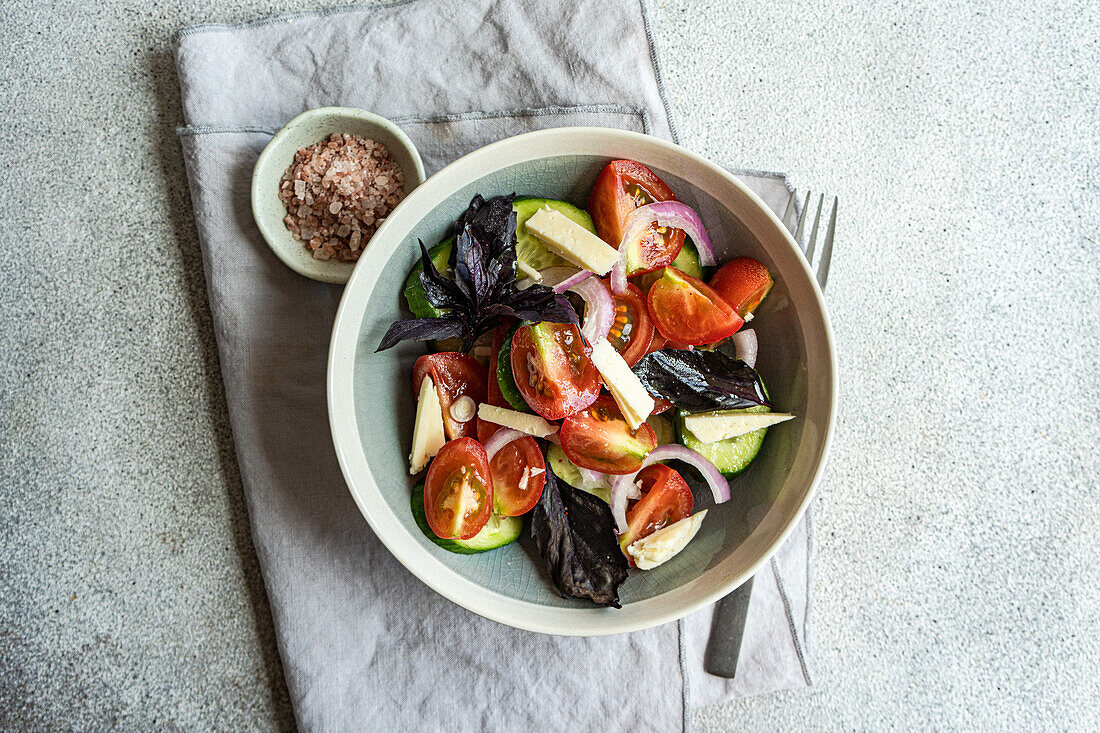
[424,438,493,539]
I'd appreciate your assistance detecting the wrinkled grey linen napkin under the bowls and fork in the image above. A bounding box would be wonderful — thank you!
[176,0,812,731]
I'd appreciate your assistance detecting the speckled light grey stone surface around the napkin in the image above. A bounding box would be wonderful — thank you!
[0,0,1100,731]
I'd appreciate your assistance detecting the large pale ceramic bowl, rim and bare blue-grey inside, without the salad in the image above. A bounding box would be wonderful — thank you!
[328,128,836,636]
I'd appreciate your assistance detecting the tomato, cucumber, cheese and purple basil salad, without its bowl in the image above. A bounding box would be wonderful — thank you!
[378,160,794,608]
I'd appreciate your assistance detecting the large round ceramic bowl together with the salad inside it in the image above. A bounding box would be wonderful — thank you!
[328,128,836,635]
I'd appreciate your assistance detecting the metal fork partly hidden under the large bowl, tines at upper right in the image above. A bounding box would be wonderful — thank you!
[704,190,837,679]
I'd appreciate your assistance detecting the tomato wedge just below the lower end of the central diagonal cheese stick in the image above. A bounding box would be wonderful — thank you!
[559,394,657,473]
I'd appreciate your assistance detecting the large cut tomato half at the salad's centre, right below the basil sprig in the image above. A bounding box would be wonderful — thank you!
[512,322,600,420]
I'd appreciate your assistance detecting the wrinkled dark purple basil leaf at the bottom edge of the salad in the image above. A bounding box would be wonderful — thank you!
[531,458,627,609]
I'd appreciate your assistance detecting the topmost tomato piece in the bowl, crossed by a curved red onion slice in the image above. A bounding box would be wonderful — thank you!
[589,161,684,272]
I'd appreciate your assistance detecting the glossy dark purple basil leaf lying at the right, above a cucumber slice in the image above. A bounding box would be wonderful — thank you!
[633,349,771,413]
